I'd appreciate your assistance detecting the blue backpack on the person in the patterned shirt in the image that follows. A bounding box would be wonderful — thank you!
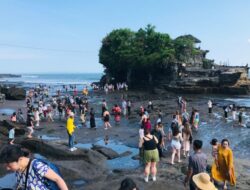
[35,158,62,190]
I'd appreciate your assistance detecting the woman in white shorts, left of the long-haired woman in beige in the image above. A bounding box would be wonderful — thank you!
[171,122,183,165]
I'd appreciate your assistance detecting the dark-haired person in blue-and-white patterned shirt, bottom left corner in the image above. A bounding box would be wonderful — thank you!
[0,145,68,190]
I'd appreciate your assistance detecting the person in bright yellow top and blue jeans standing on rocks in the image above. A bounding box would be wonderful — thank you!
[66,112,77,151]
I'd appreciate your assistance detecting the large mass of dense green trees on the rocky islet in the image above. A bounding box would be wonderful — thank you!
[99,25,211,84]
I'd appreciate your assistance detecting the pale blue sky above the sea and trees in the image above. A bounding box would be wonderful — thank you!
[0,0,250,73]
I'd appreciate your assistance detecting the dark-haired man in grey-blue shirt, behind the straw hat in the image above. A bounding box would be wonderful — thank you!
[184,140,207,190]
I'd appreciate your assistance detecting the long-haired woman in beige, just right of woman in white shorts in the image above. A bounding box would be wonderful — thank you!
[182,123,192,158]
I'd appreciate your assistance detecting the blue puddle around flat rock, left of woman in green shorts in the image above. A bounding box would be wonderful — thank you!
[76,139,140,170]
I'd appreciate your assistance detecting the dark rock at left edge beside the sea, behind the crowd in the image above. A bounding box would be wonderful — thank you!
[0,87,26,100]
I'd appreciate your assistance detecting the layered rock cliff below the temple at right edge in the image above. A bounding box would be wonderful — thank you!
[160,65,250,95]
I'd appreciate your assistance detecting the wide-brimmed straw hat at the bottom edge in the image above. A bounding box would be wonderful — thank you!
[193,173,217,190]
